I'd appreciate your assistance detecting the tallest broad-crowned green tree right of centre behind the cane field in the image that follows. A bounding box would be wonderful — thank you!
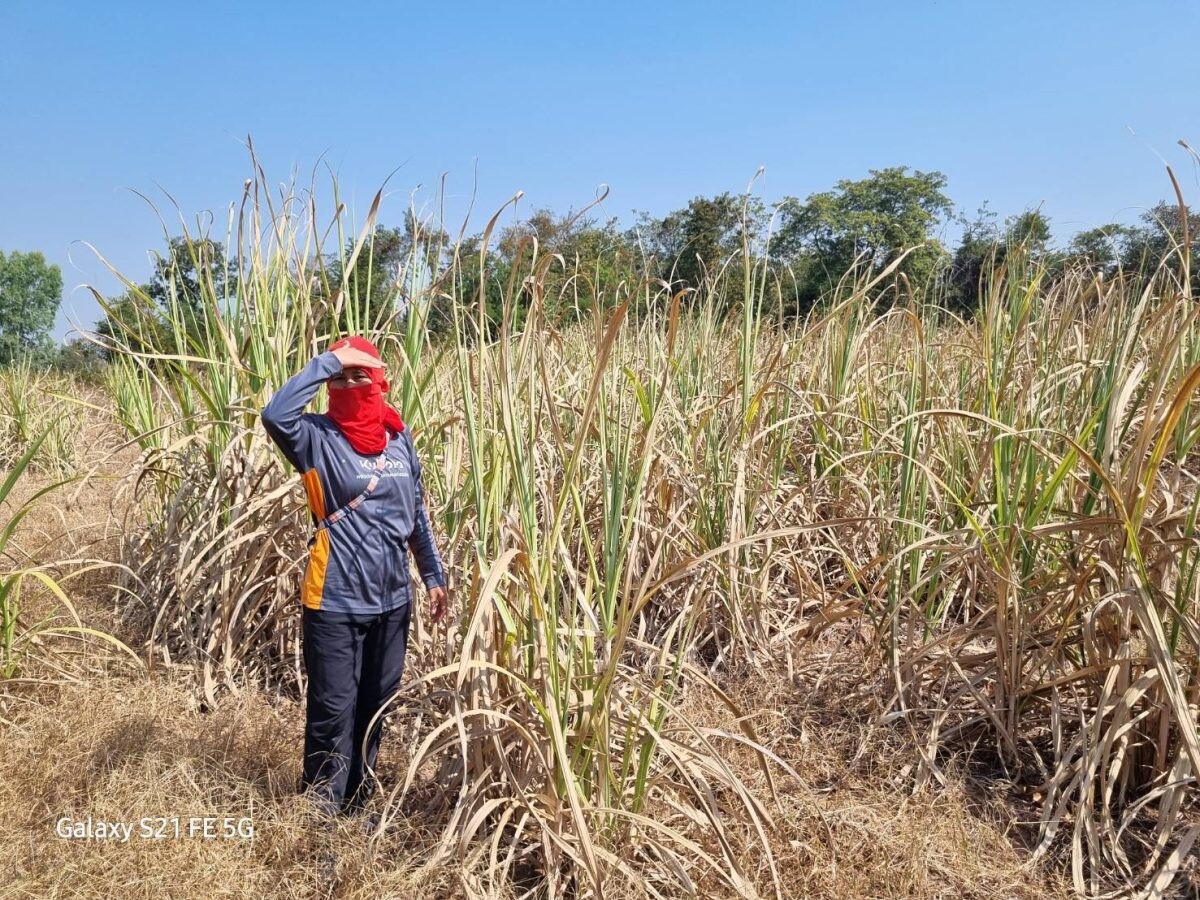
[772,166,954,311]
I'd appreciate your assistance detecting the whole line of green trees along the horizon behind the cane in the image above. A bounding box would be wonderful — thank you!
[0,167,1200,368]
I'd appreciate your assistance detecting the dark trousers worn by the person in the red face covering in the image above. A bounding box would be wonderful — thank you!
[300,602,412,814]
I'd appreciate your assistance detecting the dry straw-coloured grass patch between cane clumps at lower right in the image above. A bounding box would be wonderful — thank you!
[691,642,1069,898]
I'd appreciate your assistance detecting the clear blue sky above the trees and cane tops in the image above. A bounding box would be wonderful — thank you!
[0,0,1200,337]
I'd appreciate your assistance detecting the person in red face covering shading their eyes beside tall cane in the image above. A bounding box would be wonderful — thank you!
[262,336,448,815]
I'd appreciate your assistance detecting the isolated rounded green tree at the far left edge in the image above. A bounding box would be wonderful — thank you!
[0,251,62,364]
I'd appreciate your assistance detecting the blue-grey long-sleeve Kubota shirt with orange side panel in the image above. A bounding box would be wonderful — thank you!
[263,353,445,614]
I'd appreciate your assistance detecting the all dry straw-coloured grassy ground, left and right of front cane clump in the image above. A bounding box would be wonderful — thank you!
[0,427,1069,900]
